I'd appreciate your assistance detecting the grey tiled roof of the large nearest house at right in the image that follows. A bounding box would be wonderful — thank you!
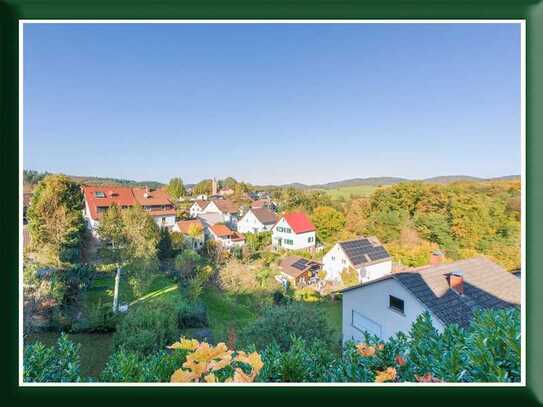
[344,257,521,327]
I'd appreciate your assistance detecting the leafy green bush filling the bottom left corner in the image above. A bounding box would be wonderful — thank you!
[23,334,82,383]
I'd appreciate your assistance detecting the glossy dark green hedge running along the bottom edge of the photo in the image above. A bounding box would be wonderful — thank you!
[24,309,520,383]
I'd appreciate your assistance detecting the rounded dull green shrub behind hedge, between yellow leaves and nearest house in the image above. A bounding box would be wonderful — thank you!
[241,303,334,350]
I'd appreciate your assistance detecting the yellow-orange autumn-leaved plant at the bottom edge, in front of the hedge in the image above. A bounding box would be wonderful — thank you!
[169,338,263,383]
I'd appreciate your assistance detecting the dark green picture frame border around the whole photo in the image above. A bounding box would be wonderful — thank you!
[0,0,543,406]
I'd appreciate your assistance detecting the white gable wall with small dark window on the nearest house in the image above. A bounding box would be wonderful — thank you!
[342,278,444,343]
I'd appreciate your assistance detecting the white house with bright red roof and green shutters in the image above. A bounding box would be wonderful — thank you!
[272,212,316,250]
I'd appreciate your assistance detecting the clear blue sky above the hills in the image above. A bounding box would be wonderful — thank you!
[24,24,521,184]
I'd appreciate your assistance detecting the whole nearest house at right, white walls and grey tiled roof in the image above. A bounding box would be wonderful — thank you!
[341,257,521,342]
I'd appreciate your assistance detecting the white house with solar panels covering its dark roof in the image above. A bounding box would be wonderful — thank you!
[322,237,392,283]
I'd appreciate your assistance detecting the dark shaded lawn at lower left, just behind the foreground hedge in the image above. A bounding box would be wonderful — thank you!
[25,332,113,378]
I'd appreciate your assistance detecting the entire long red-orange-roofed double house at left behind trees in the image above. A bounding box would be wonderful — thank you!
[83,186,175,236]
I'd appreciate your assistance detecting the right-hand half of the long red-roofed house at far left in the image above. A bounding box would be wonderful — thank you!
[132,188,176,229]
